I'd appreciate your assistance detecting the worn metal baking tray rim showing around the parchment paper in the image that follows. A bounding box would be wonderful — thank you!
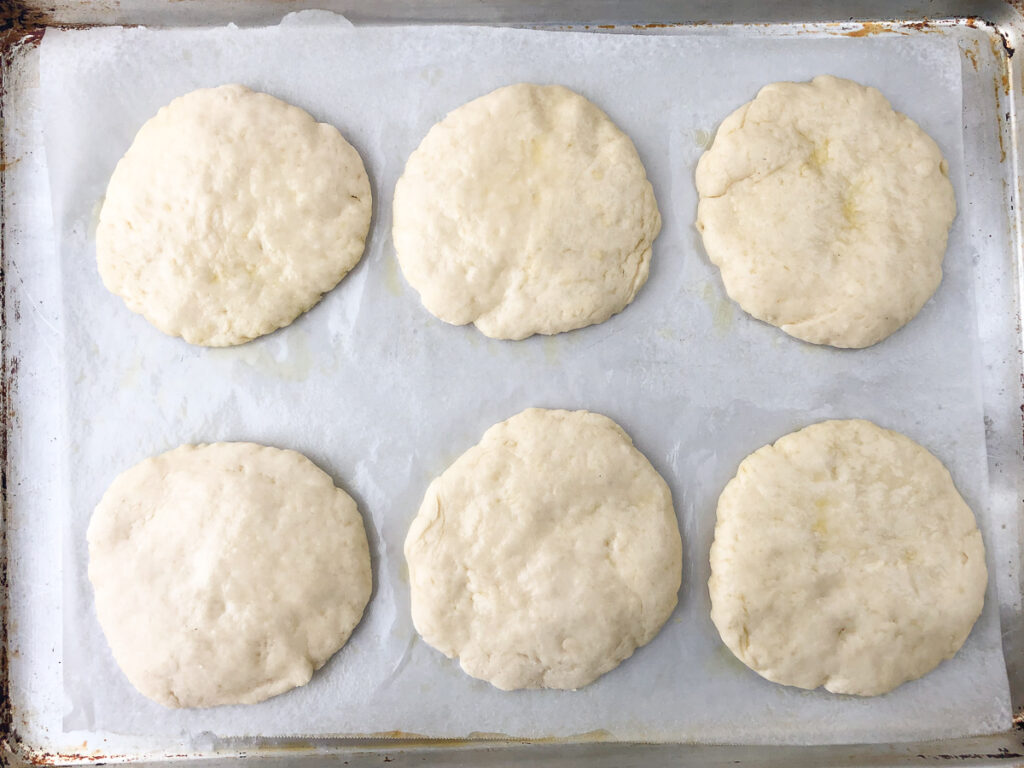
[0,0,1024,768]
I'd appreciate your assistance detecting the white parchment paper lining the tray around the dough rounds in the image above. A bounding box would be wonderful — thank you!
[41,14,1010,743]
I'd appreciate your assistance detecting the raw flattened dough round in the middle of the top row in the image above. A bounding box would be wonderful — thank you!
[393,84,662,339]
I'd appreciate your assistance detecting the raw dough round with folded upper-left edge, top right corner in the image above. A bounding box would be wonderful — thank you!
[696,76,956,347]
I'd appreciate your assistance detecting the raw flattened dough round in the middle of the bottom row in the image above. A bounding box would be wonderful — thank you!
[406,409,682,690]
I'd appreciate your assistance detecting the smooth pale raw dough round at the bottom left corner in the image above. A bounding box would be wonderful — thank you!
[88,442,371,707]
